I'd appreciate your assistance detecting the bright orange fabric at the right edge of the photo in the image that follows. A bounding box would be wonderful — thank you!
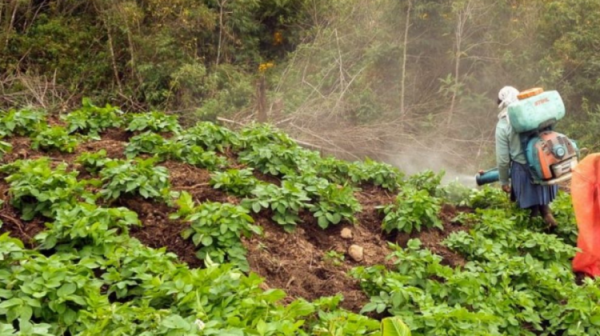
[571,154,600,277]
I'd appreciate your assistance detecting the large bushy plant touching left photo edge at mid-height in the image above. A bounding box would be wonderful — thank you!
[0,158,93,220]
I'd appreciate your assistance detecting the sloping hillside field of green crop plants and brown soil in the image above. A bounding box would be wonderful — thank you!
[0,102,600,335]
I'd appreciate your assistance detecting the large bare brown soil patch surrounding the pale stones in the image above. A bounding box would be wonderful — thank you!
[244,187,393,312]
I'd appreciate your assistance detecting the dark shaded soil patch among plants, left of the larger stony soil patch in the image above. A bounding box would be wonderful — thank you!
[120,197,203,268]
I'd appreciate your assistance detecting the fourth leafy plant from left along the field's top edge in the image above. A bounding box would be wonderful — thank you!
[177,122,239,153]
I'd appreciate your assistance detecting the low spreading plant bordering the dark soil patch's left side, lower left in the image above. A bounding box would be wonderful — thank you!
[35,203,141,250]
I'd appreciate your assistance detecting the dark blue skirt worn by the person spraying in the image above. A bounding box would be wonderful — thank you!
[510,161,558,209]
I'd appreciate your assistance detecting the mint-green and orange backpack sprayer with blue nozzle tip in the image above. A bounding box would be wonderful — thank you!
[475,88,579,186]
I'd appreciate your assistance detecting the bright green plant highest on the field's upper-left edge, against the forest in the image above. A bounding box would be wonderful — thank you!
[62,98,124,139]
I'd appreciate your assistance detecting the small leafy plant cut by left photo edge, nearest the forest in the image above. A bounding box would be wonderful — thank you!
[0,108,46,138]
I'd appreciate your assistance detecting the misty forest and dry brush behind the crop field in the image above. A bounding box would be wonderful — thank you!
[0,0,600,176]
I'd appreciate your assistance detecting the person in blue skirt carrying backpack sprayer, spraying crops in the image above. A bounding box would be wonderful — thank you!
[476,86,579,227]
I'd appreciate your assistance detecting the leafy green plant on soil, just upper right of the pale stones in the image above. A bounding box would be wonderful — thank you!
[382,188,443,233]
